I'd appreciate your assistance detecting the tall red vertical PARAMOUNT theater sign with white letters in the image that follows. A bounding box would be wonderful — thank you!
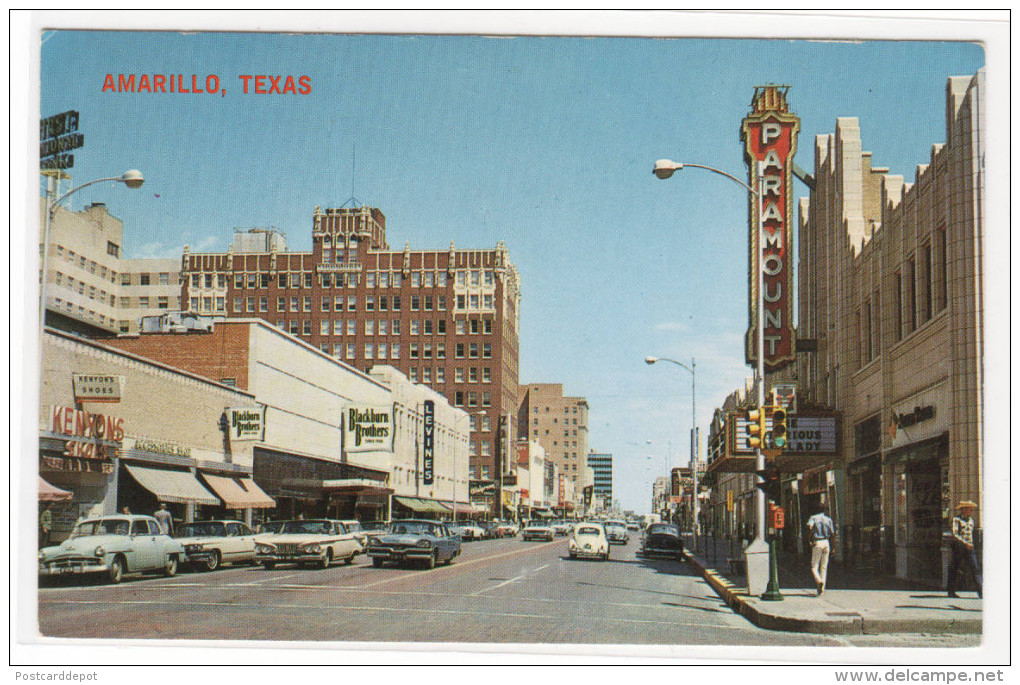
[741,86,801,370]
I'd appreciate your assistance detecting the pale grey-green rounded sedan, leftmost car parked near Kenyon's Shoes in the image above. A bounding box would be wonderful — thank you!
[39,514,185,583]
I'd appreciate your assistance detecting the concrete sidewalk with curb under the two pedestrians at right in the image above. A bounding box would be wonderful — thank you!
[685,538,982,635]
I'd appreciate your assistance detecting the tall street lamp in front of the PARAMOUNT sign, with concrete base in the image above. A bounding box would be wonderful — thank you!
[652,154,782,599]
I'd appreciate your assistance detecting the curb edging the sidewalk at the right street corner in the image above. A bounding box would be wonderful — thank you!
[683,549,982,635]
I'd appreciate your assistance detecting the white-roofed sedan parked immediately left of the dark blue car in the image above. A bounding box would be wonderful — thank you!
[255,519,364,569]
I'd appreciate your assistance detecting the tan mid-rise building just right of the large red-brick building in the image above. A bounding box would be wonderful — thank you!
[517,383,588,489]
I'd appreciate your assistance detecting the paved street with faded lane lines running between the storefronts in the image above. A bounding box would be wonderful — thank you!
[39,536,975,646]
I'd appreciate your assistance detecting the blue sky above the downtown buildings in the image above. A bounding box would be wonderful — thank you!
[40,26,985,511]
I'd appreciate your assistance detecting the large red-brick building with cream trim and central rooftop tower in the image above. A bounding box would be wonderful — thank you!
[181,207,520,489]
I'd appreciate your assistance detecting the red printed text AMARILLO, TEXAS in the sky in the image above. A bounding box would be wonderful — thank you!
[102,73,312,95]
